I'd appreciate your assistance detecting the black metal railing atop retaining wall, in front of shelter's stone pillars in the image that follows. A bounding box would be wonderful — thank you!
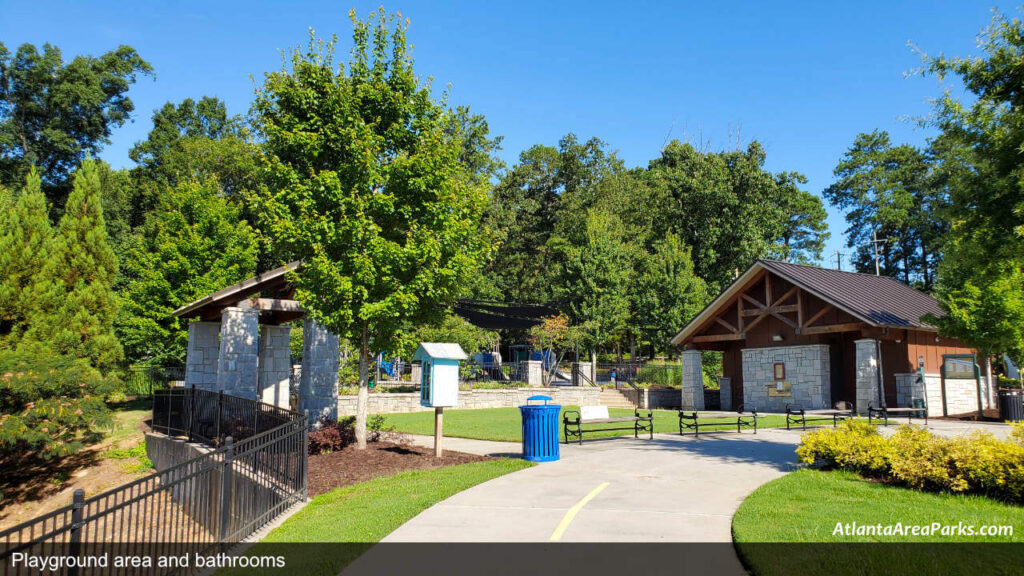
[151,386,302,447]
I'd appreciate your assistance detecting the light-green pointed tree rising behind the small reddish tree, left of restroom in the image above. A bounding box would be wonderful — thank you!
[550,209,636,357]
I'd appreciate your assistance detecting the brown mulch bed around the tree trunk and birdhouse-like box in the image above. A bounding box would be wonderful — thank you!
[309,442,493,496]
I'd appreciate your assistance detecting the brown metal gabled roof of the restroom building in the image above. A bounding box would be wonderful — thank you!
[672,260,945,345]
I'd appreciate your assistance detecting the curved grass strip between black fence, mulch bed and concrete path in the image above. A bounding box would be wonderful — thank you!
[227,458,534,575]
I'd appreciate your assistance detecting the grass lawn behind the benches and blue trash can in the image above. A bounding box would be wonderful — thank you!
[385,406,785,442]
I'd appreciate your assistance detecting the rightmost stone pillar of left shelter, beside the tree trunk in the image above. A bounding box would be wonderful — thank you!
[299,318,339,424]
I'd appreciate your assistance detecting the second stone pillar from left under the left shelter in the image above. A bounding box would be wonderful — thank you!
[217,307,259,400]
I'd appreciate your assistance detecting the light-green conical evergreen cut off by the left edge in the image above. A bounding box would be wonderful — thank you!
[0,168,53,347]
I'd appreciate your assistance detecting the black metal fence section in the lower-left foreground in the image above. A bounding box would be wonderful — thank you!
[0,390,307,575]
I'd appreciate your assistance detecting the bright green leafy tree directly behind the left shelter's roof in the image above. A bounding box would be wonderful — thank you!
[116,178,258,366]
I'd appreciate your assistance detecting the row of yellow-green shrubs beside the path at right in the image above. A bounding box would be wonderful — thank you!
[797,421,1024,503]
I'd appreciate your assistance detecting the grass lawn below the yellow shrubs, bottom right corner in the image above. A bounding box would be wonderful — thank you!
[732,469,1024,575]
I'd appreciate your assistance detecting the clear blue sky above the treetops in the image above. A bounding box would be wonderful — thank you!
[0,0,1016,261]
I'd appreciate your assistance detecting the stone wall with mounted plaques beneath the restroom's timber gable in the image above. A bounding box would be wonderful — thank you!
[741,344,831,412]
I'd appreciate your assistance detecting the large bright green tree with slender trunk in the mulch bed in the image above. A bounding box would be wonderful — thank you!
[254,9,488,448]
